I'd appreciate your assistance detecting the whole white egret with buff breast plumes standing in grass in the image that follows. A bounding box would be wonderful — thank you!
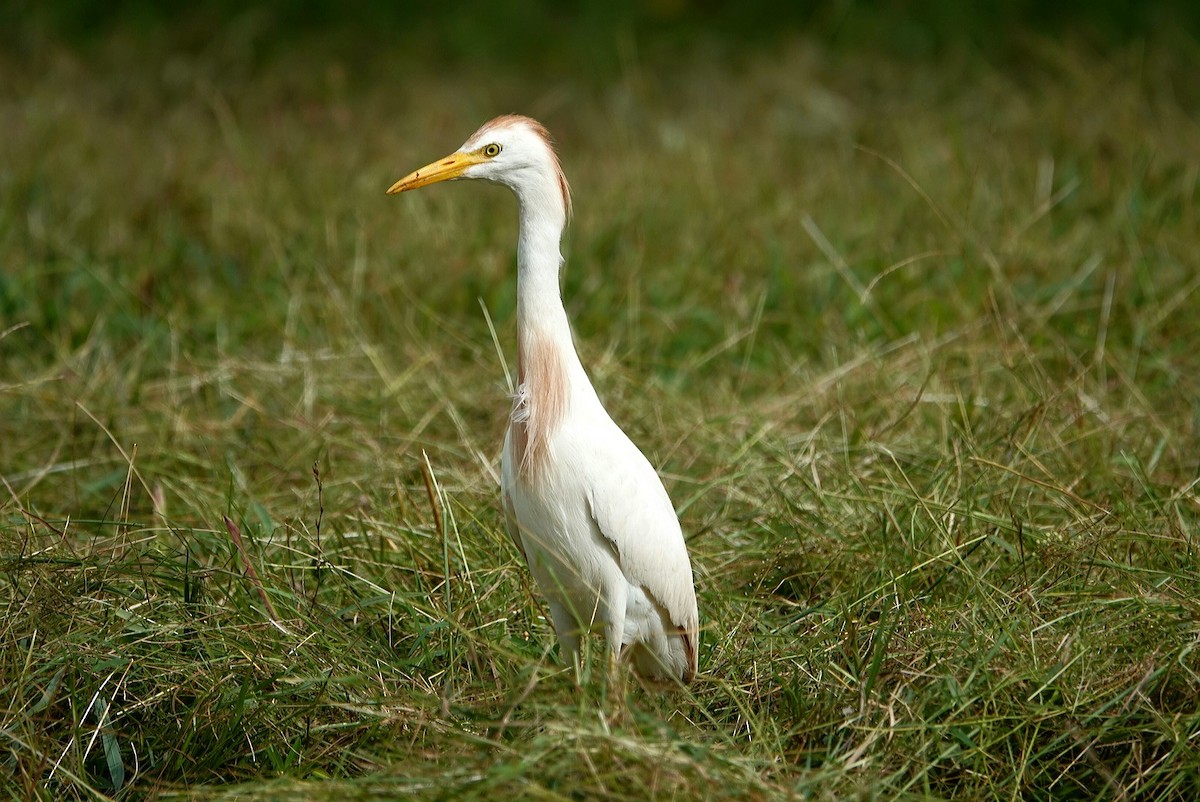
[388,115,700,682]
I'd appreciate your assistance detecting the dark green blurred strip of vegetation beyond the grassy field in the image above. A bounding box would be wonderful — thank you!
[2,0,1200,64]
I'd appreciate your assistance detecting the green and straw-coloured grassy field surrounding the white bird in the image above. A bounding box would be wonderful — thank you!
[0,4,1200,800]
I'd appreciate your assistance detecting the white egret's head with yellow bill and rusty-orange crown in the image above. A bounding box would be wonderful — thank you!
[388,114,571,215]
